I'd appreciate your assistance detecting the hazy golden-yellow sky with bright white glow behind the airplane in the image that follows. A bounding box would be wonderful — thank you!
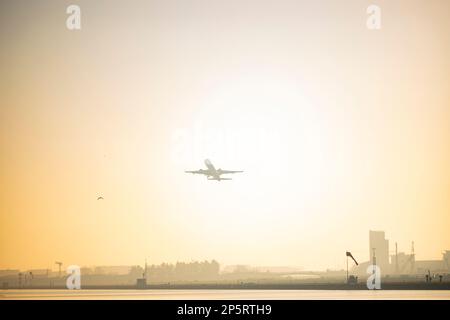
[0,0,450,270]
